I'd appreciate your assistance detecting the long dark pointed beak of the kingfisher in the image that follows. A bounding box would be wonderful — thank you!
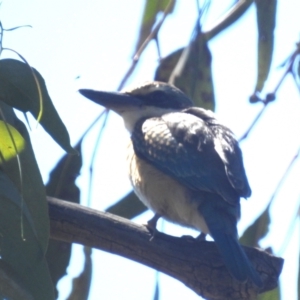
[79,89,142,112]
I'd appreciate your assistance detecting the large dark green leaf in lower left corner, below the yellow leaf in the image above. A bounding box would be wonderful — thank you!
[0,170,54,300]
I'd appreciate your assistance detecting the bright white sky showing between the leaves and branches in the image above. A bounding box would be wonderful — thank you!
[0,0,300,300]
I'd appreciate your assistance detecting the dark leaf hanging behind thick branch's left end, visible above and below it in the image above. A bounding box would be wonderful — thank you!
[46,142,82,296]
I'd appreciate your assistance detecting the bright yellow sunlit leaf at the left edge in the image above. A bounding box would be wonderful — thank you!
[0,121,25,164]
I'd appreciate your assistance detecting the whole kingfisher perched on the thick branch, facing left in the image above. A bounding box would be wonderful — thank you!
[79,81,262,287]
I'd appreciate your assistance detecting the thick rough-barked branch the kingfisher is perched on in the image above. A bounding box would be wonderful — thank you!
[48,197,283,300]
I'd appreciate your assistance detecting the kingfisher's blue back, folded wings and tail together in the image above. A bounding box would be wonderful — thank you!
[131,112,262,286]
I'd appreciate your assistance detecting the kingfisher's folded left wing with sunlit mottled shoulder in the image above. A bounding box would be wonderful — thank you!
[131,112,248,204]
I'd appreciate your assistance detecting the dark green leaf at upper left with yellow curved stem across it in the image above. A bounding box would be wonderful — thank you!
[0,59,74,153]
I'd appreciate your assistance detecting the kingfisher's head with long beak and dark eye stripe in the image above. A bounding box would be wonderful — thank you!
[79,81,193,132]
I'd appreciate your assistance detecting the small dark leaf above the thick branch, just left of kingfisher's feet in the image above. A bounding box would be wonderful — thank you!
[106,192,148,219]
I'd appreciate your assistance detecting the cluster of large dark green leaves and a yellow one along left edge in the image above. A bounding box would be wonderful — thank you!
[0,55,75,299]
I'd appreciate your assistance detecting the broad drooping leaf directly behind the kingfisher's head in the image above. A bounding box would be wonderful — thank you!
[155,32,215,110]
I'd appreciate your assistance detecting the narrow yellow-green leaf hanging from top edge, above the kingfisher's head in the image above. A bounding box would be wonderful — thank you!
[135,0,176,52]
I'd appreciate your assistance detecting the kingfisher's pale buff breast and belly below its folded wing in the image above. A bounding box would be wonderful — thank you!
[127,142,209,233]
